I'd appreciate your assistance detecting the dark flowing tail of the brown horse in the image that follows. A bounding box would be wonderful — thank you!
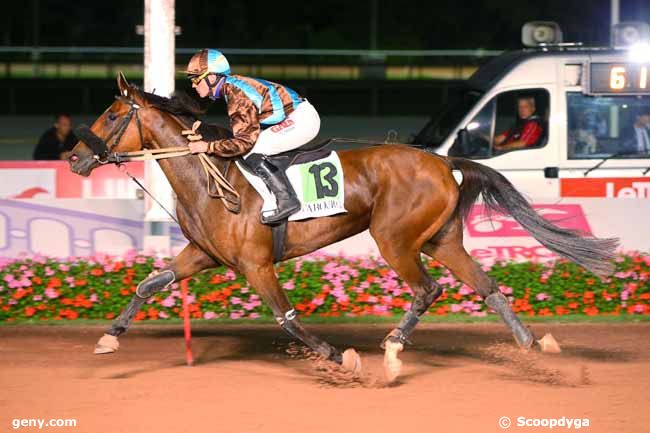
[448,157,618,277]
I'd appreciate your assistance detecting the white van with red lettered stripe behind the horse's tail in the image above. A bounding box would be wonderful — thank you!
[414,23,650,198]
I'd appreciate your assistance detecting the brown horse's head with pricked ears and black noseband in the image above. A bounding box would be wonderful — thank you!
[67,73,148,176]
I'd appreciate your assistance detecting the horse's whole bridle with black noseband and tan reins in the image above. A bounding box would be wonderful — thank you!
[75,95,241,213]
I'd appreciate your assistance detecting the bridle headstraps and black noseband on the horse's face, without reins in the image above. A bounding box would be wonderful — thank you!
[75,96,144,164]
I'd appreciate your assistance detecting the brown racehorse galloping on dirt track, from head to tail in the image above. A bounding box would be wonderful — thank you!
[68,73,617,380]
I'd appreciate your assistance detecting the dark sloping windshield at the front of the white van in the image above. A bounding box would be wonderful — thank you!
[412,90,483,149]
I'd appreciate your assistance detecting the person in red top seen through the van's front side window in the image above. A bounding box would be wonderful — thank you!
[494,96,544,151]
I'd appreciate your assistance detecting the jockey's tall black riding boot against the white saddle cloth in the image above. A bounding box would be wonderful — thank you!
[245,154,301,224]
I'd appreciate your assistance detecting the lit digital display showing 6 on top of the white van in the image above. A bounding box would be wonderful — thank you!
[589,62,650,95]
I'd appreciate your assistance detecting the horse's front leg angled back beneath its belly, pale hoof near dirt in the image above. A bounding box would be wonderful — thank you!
[241,264,361,374]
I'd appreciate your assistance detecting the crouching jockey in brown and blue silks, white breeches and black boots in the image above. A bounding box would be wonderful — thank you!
[185,49,320,224]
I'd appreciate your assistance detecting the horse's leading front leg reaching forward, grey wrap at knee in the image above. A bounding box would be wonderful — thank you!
[95,243,217,354]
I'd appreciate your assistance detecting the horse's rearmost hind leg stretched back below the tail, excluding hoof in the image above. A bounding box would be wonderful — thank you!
[422,218,535,349]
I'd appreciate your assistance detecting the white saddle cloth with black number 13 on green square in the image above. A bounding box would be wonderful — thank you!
[237,151,347,221]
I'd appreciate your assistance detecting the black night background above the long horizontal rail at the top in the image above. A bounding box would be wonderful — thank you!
[0,0,650,49]
